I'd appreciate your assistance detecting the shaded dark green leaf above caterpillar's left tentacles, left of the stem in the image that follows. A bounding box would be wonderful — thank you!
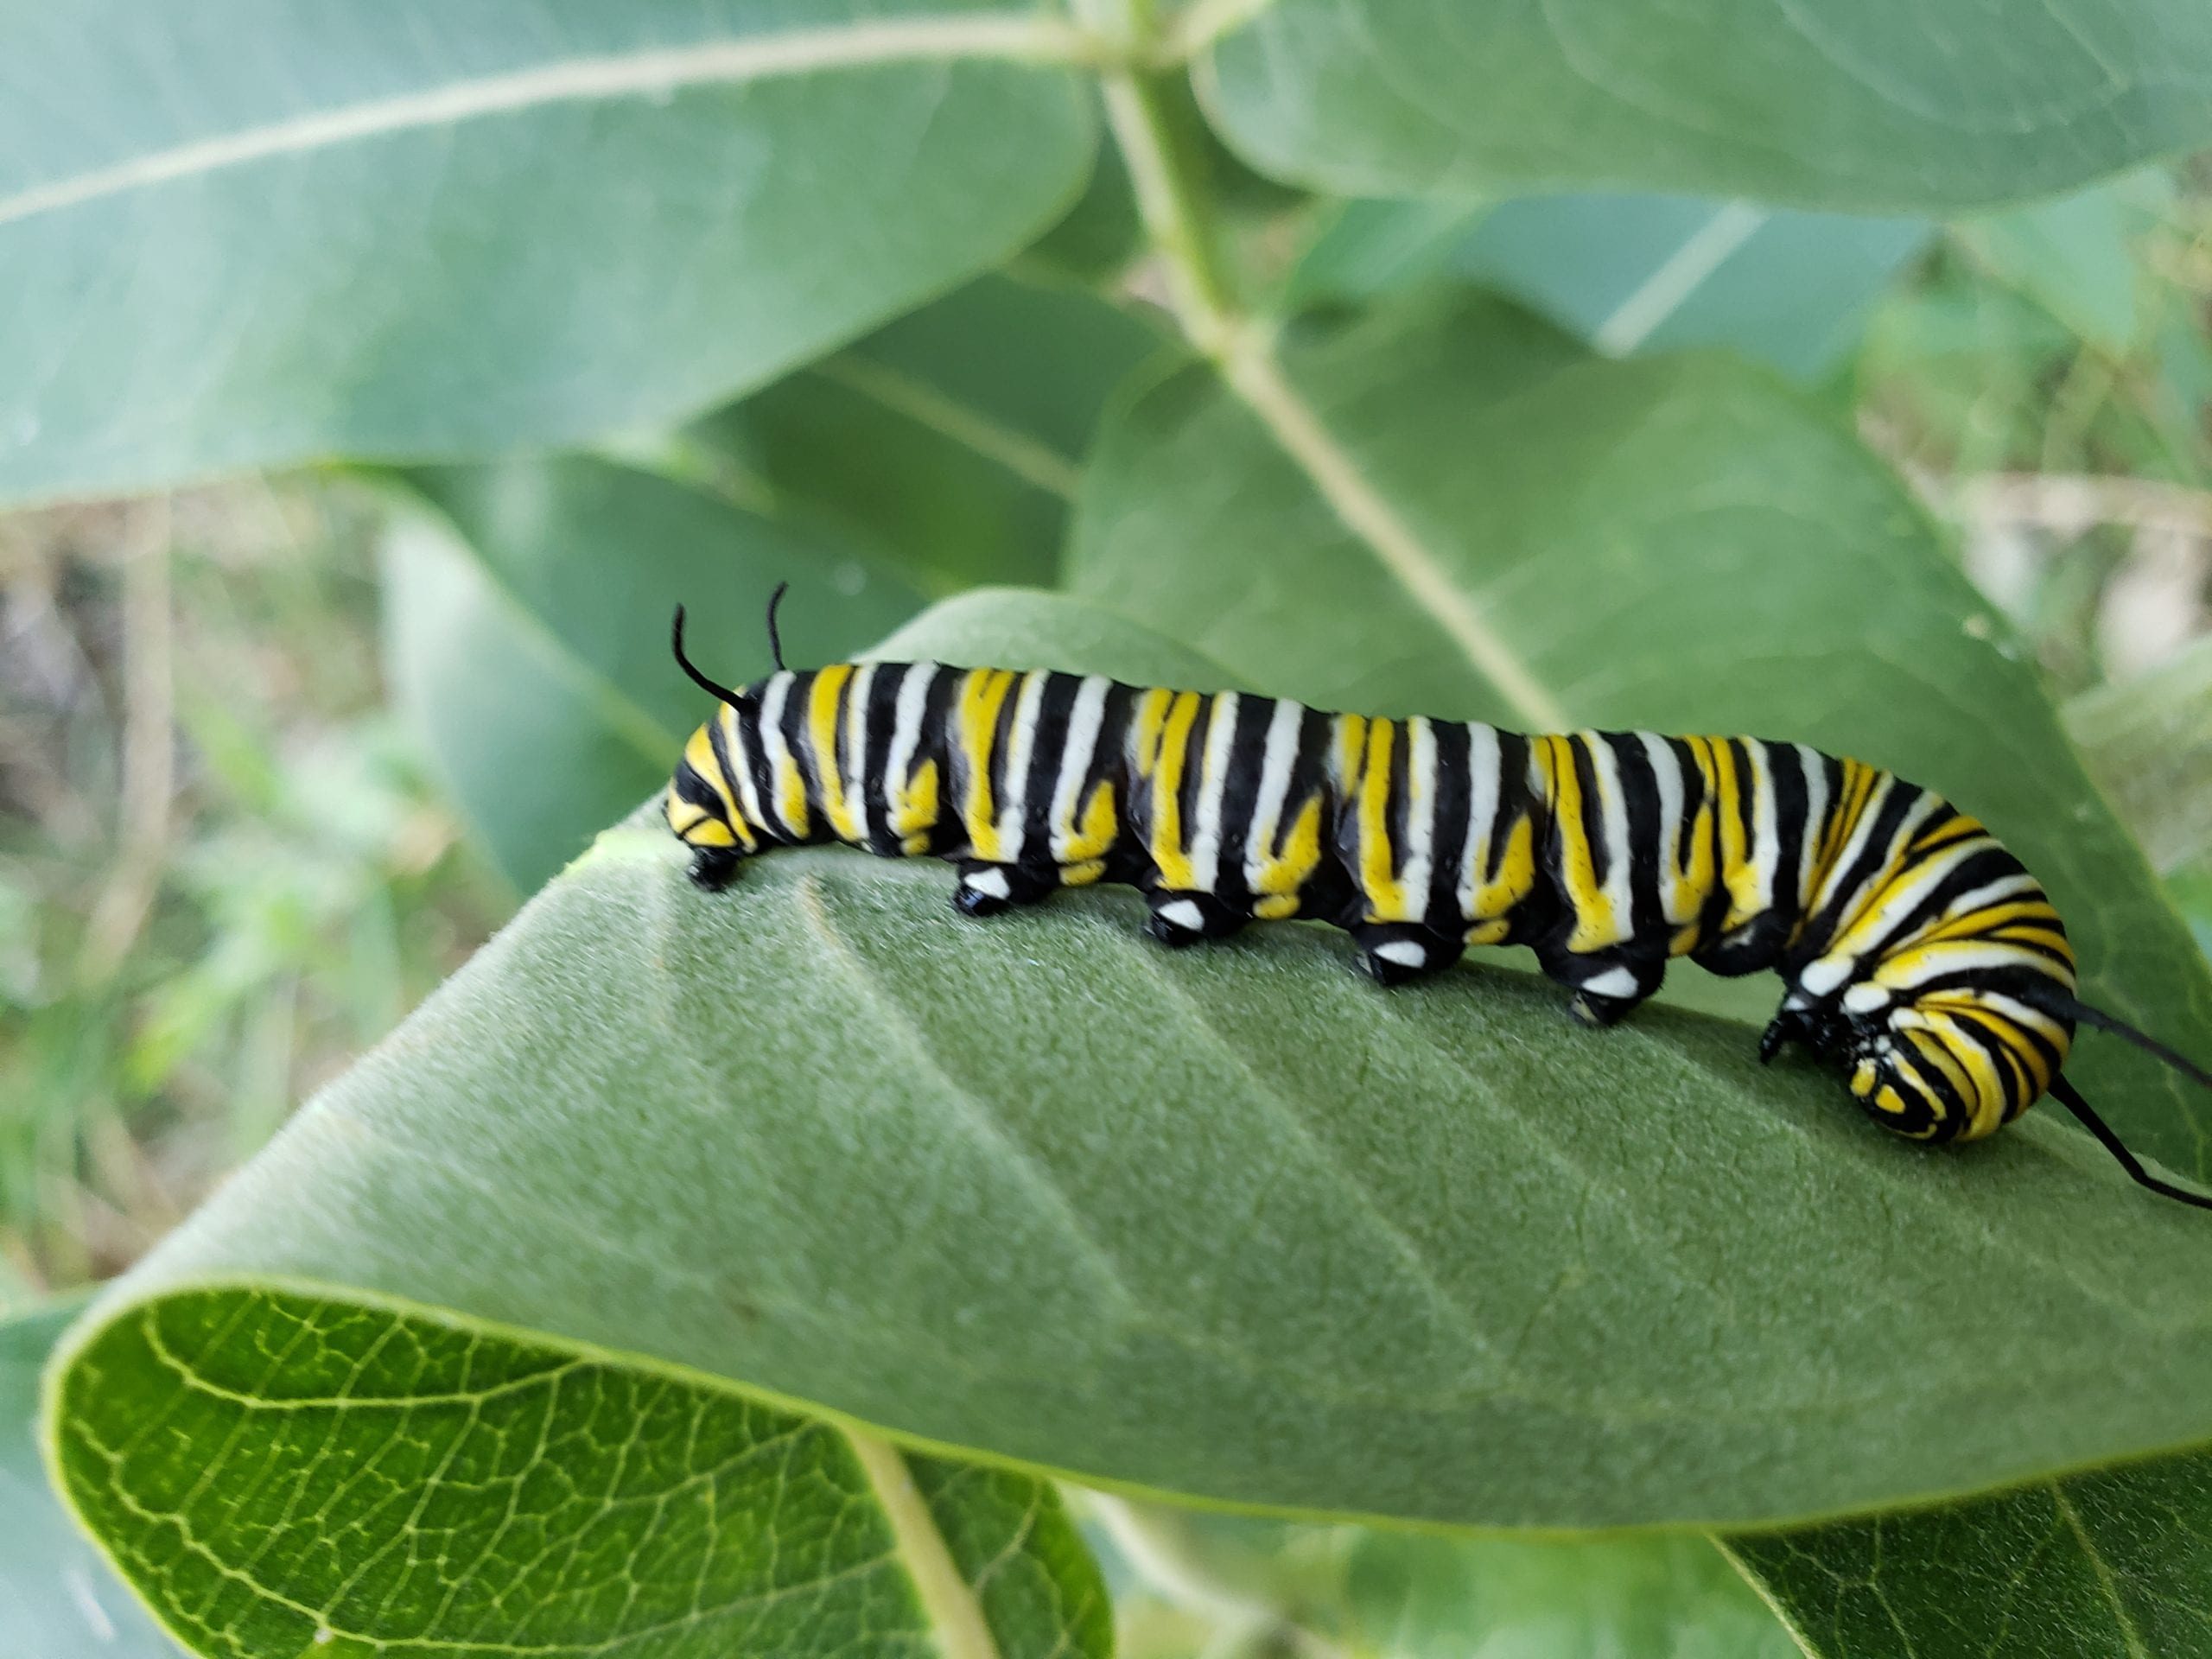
[695,276,1161,591]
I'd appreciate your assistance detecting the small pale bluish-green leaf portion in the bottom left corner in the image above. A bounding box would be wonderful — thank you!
[0,1299,177,1659]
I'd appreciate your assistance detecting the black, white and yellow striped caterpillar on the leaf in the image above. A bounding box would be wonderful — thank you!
[664,586,2212,1208]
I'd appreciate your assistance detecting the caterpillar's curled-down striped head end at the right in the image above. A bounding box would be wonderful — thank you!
[1758,964,2073,1141]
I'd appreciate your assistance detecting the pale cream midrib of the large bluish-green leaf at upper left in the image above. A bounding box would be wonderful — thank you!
[0,16,1084,226]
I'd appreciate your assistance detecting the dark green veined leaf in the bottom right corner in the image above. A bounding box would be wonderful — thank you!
[1730,1455,2212,1659]
